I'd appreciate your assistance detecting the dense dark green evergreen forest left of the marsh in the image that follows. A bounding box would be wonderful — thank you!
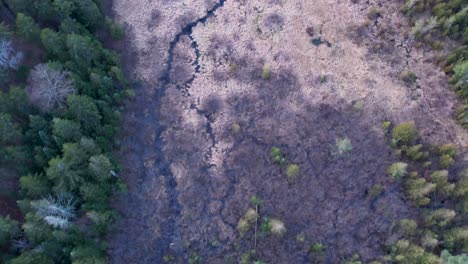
[0,0,131,264]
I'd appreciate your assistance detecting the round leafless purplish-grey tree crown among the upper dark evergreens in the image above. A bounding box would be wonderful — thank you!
[27,64,75,112]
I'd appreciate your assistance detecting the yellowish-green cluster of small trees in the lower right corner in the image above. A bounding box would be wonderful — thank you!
[378,122,468,264]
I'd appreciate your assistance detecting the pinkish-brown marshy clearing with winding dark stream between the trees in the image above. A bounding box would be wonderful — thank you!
[109,0,468,263]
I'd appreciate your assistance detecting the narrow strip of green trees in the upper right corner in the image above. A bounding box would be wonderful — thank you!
[402,0,468,128]
